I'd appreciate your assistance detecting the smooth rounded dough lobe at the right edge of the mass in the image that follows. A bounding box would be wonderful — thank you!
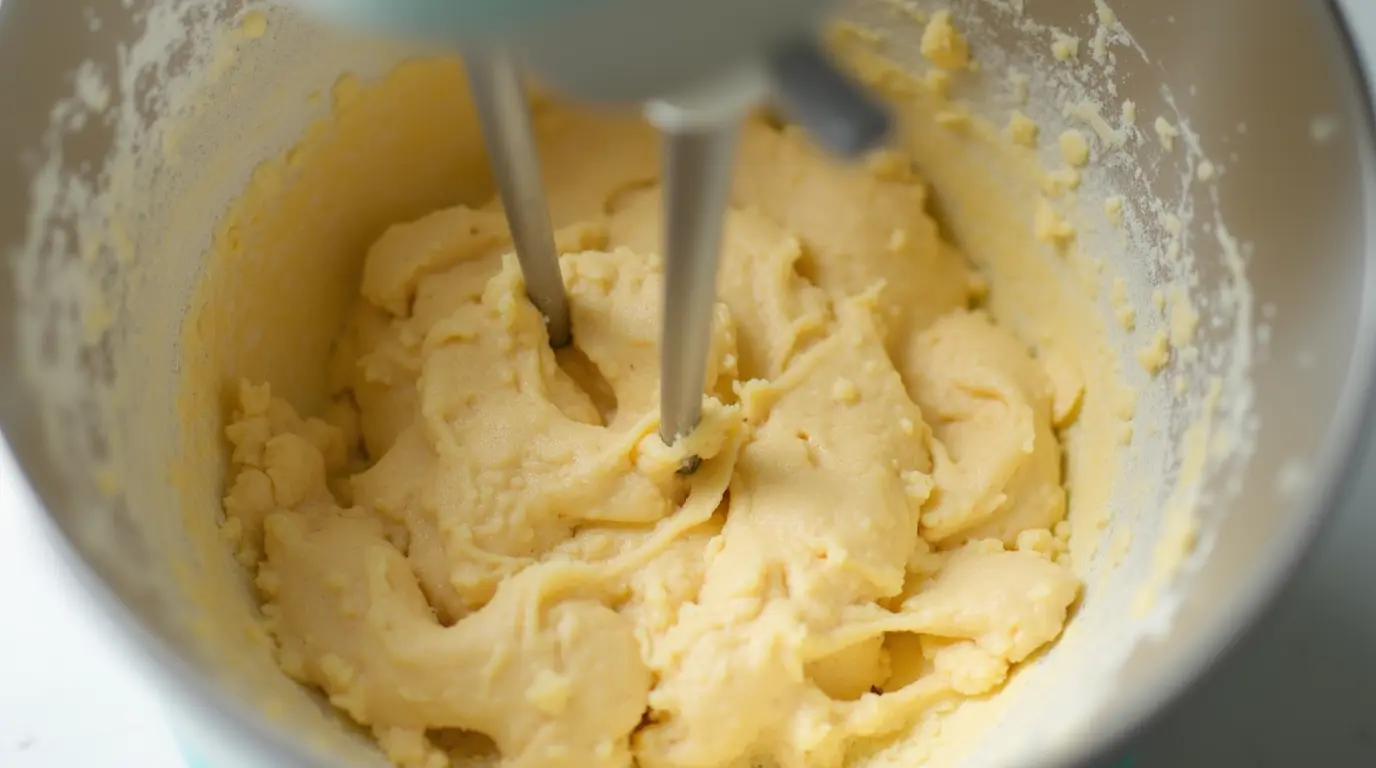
[910,312,1065,545]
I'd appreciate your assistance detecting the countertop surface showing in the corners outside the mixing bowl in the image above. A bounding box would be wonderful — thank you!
[0,0,1376,768]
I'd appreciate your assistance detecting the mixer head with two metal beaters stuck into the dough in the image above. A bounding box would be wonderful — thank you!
[297,0,889,456]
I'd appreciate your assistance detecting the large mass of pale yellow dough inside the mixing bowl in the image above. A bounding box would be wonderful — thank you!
[224,96,1082,768]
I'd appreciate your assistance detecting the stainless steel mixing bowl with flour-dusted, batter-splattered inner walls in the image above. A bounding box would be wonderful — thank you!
[0,0,1376,765]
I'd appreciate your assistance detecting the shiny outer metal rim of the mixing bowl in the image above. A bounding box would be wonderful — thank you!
[0,0,1376,767]
